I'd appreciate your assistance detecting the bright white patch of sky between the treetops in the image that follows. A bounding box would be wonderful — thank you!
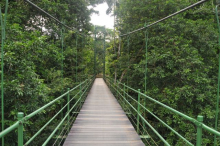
[90,3,114,29]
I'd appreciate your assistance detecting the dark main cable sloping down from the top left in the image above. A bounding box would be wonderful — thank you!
[25,0,86,36]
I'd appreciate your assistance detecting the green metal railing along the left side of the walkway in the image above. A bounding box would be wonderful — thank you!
[0,76,95,146]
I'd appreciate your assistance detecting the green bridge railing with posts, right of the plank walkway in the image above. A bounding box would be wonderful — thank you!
[105,77,220,146]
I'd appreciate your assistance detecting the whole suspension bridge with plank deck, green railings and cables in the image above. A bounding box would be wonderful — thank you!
[0,0,220,146]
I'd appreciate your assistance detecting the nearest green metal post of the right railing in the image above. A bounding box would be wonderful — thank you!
[196,116,203,146]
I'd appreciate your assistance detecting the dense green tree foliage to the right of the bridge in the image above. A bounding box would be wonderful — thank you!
[108,0,219,145]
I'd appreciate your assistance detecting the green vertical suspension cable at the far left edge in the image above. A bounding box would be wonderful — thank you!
[0,0,8,146]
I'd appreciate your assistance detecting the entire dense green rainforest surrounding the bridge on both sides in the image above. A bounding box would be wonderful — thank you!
[0,0,220,146]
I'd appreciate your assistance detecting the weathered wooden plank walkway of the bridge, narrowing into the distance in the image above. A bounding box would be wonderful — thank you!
[64,78,144,146]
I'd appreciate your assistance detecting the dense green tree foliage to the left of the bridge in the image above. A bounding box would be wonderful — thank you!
[0,0,96,146]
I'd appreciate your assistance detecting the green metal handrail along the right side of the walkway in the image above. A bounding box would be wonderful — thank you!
[105,77,220,146]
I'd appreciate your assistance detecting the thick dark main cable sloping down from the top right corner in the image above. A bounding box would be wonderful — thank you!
[121,0,208,37]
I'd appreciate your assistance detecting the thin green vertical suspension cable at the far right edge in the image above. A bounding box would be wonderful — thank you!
[214,5,220,146]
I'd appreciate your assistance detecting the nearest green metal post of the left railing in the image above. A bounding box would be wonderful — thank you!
[18,112,24,146]
